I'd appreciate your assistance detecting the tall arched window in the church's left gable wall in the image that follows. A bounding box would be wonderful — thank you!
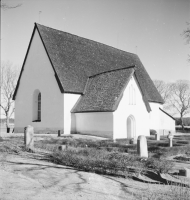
[32,90,42,122]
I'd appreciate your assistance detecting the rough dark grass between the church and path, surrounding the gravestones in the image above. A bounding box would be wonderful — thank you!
[30,136,190,177]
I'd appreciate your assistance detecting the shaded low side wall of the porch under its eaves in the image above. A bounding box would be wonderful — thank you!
[72,112,113,138]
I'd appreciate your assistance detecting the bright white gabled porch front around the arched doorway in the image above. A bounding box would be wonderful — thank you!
[114,77,150,139]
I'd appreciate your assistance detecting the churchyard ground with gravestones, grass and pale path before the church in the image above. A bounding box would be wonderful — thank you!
[0,127,190,199]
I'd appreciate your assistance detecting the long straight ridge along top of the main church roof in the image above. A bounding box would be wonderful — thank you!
[34,22,138,57]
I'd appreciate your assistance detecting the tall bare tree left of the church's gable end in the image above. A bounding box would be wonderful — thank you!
[0,61,18,131]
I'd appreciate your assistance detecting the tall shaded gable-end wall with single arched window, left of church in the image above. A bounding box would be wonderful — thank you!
[15,31,63,132]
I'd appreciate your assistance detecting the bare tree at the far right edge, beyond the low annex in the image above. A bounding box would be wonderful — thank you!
[168,80,190,130]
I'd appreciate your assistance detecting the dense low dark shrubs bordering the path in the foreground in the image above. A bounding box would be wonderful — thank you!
[46,147,144,175]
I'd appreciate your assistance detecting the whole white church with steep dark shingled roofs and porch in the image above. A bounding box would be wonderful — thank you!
[13,23,175,139]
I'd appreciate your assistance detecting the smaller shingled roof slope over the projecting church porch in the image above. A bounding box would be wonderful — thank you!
[71,67,135,113]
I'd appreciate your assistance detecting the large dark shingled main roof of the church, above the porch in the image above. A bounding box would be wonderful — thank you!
[14,23,163,103]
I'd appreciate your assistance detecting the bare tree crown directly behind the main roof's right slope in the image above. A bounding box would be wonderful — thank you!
[153,80,171,102]
